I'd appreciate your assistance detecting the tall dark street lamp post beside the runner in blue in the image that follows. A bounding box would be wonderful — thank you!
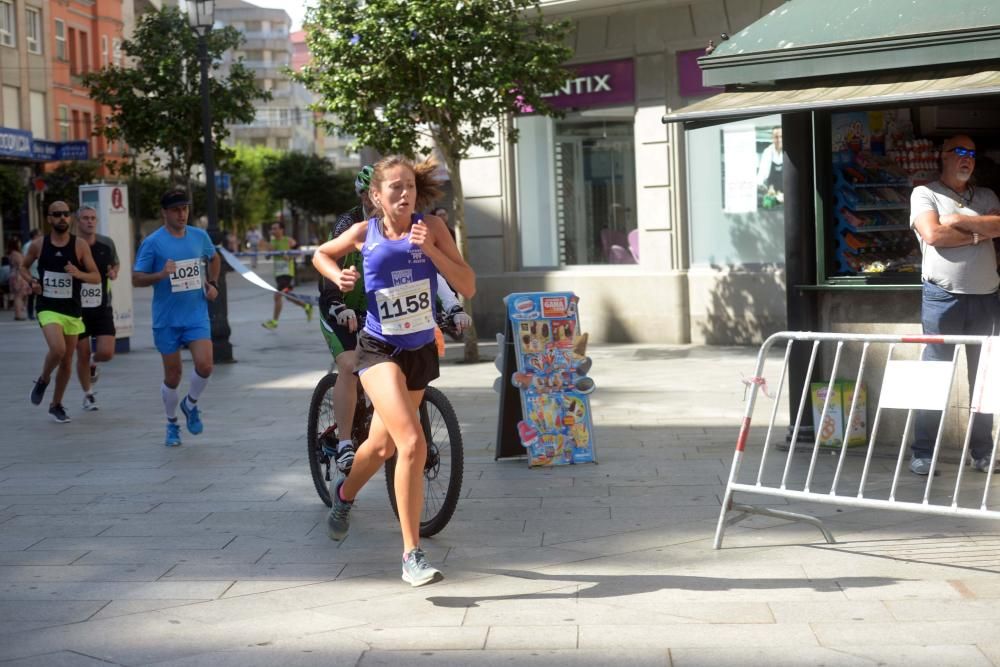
[188,0,235,363]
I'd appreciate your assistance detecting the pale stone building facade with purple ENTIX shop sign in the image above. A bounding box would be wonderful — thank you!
[462,0,784,343]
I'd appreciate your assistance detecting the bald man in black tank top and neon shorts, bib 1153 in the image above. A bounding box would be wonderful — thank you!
[21,201,101,423]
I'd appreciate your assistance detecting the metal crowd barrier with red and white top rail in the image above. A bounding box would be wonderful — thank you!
[714,331,1000,549]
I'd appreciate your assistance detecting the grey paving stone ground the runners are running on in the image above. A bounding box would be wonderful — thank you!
[0,274,1000,667]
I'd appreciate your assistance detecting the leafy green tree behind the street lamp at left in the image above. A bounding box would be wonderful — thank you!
[84,7,271,182]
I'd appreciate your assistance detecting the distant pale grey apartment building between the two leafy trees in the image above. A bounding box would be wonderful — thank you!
[215,0,315,152]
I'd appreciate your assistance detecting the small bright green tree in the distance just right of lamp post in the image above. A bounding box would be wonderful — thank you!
[221,144,280,236]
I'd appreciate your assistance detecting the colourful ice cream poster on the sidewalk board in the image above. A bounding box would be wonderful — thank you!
[505,292,597,466]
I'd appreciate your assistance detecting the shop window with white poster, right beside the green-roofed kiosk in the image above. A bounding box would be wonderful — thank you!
[686,116,785,266]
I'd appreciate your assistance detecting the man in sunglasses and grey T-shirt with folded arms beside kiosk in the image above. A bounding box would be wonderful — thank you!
[910,134,1000,475]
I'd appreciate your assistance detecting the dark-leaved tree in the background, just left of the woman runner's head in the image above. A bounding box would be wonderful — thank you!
[264,151,357,242]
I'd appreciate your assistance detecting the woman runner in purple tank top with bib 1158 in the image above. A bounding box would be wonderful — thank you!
[313,155,476,586]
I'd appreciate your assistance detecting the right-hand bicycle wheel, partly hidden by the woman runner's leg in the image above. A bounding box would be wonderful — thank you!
[385,387,465,537]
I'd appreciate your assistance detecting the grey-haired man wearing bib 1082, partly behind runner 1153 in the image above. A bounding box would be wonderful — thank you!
[76,205,119,411]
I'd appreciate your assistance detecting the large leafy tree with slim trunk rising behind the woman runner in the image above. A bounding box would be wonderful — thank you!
[297,0,572,361]
